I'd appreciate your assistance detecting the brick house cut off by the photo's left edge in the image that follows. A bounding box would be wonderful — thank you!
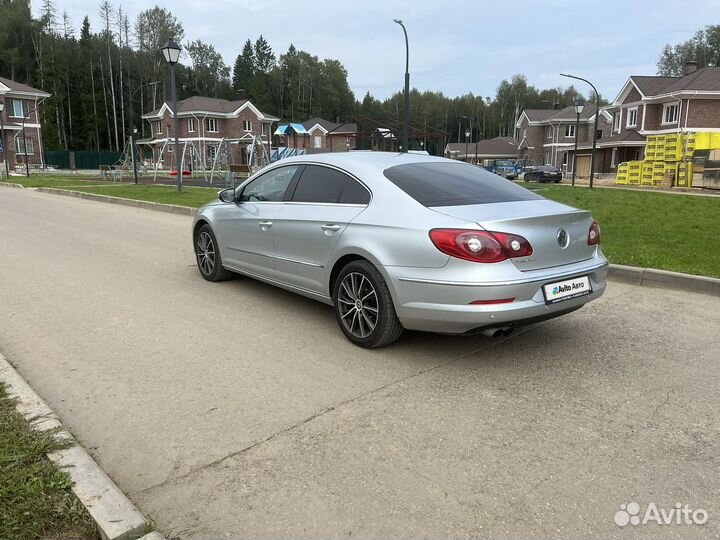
[0,77,50,174]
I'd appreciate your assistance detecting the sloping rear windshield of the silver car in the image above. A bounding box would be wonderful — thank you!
[384,163,542,206]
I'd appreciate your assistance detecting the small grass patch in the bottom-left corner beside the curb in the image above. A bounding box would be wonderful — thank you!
[0,383,99,540]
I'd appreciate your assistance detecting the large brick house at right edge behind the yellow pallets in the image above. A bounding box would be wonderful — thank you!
[578,62,720,173]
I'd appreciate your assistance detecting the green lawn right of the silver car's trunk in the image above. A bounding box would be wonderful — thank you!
[533,186,720,277]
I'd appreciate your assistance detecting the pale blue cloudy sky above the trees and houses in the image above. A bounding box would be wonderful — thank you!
[33,0,720,100]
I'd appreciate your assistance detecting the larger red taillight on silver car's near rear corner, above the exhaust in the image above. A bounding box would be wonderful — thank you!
[430,229,533,263]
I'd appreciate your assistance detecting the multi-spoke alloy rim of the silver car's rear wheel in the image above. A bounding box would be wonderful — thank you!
[338,272,378,339]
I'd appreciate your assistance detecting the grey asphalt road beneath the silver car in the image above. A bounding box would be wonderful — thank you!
[0,188,720,539]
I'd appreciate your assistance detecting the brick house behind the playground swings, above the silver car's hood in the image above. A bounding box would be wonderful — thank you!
[138,96,278,168]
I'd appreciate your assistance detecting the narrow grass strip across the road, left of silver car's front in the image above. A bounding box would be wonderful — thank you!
[65,184,220,208]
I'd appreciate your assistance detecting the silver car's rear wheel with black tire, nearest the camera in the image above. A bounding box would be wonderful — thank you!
[333,260,403,349]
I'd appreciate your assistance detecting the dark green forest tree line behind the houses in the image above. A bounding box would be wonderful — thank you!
[0,0,652,153]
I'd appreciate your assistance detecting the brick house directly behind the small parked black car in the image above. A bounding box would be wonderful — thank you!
[515,104,612,172]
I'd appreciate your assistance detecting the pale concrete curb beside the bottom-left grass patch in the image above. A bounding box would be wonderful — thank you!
[0,354,165,540]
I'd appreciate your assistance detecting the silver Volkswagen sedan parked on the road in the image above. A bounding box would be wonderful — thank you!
[192,152,608,347]
